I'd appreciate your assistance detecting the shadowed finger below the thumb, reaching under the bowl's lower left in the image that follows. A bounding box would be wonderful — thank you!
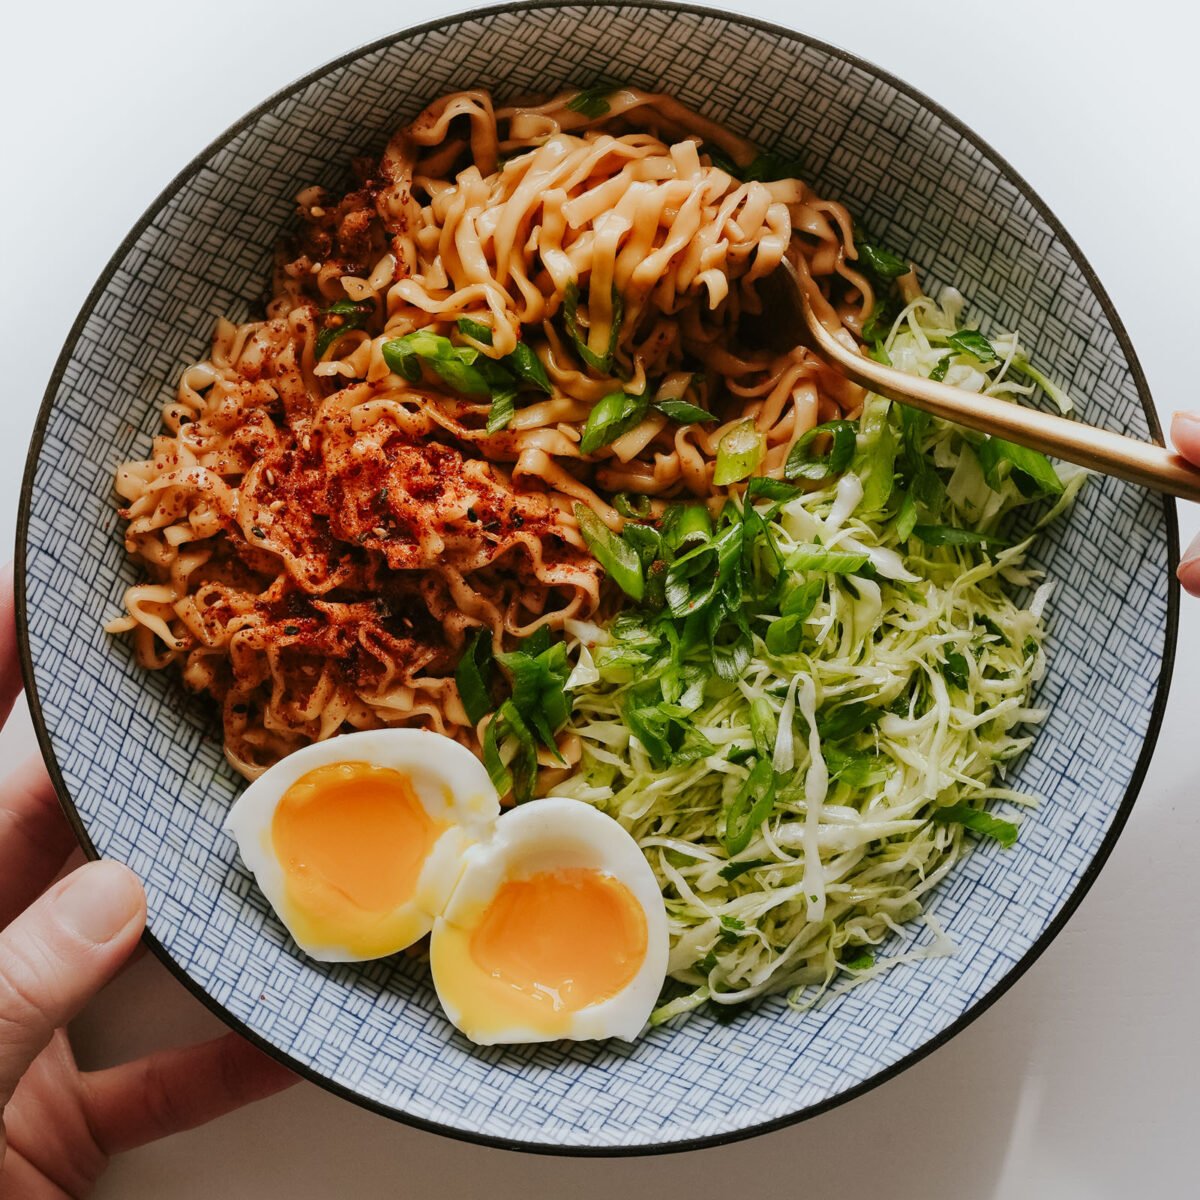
[83,1033,296,1154]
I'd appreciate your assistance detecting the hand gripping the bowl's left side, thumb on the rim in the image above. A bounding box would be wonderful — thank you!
[0,571,295,1200]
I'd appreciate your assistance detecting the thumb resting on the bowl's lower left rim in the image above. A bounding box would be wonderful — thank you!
[0,862,146,1109]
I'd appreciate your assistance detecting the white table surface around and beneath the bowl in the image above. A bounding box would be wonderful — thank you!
[0,0,1200,1200]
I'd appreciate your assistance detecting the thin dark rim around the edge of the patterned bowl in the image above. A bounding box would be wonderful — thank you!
[13,0,1180,1158]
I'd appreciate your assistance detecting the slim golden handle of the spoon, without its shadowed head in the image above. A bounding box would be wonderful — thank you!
[803,298,1200,500]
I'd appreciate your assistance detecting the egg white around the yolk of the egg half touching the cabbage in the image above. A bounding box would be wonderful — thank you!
[430,797,668,1045]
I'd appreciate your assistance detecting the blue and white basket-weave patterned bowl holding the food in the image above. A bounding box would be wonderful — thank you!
[17,4,1178,1153]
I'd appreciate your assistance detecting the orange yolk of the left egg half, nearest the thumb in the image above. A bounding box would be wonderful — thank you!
[271,762,446,958]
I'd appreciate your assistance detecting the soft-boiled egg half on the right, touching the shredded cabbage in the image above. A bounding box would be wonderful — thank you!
[430,797,667,1045]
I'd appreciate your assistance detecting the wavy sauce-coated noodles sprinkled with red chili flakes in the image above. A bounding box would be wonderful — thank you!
[109,89,875,778]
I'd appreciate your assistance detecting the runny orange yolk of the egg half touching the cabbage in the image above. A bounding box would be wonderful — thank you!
[433,868,647,1036]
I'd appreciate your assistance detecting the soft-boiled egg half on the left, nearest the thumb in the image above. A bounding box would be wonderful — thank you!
[224,730,500,962]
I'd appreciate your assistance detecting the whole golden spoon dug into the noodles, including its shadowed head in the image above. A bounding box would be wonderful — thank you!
[755,258,1200,500]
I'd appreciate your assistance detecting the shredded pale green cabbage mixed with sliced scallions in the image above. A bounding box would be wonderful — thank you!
[554,293,1082,1024]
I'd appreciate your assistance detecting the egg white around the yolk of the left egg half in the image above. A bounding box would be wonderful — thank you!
[223,730,500,962]
